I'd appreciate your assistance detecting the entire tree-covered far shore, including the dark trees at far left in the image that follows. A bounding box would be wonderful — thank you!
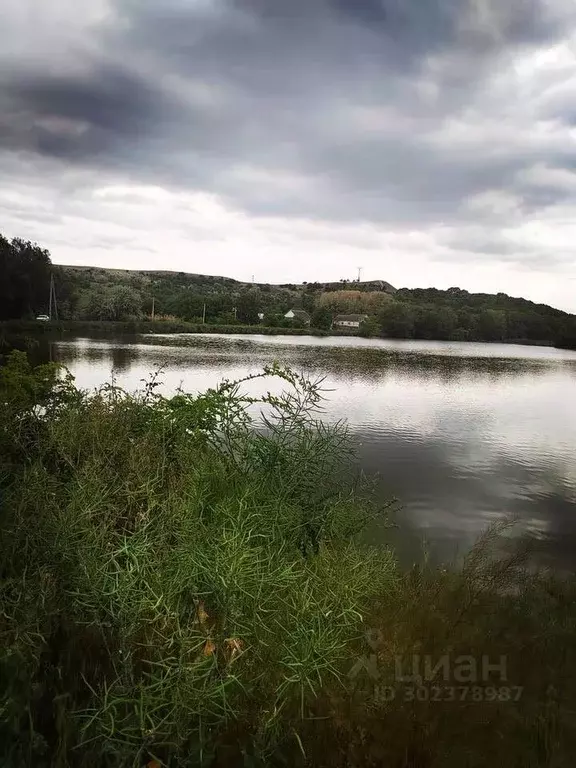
[0,230,576,348]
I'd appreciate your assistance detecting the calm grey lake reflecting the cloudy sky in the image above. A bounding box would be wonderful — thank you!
[46,334,576,569]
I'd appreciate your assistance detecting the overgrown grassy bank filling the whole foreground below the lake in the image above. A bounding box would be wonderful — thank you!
[0,353,576,768]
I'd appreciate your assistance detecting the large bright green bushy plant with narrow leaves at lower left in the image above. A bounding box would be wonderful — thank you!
[0,355,395,766]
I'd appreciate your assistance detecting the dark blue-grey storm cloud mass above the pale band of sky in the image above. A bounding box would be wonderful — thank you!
[0,0,576,252]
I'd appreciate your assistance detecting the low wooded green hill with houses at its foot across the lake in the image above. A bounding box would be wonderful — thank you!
[53,266,576,346]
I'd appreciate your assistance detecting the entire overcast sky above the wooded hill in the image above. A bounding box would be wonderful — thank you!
[0,0,576,312]
